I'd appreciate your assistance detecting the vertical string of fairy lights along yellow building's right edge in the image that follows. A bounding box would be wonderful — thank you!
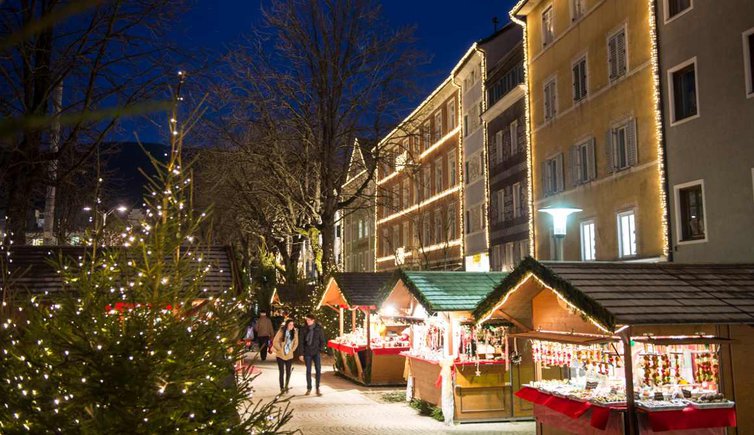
[647,0,670,259]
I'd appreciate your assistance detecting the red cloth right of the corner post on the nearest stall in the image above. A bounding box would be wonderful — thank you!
[646,406,736,432]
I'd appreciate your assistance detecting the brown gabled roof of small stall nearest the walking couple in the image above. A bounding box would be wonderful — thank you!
[320,272,392,308]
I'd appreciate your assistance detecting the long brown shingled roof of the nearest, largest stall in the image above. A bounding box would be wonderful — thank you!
[474,257,754,330]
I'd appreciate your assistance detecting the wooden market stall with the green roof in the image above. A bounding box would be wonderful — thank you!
[381,271,531,422]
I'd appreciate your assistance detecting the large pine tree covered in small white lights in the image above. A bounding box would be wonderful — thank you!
[0,73,290,434]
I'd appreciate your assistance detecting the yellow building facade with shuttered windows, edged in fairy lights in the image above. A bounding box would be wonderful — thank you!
[511,0,667,261]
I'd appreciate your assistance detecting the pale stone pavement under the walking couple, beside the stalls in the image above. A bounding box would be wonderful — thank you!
[247,356,535,435]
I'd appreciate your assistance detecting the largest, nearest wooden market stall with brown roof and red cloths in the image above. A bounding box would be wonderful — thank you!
[474,258,754,434]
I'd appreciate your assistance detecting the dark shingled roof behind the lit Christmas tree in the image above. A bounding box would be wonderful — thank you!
[2,246,240,295]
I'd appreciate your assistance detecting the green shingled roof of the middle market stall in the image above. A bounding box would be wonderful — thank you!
[395,270,507,313]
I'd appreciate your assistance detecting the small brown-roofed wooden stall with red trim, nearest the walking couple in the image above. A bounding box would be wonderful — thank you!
[318,272,408,385]
